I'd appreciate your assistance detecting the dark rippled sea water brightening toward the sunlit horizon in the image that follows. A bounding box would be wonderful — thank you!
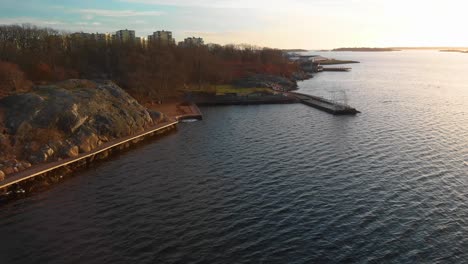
[0,52,468,263]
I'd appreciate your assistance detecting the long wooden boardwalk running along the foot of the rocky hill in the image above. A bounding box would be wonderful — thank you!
[0,105,202,200]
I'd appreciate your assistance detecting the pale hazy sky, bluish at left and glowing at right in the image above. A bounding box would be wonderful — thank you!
[0,0,468,49]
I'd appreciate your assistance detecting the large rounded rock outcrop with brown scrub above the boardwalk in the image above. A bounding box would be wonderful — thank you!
[0,80,165,179]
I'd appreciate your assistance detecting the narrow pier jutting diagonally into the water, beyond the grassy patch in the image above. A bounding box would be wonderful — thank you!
[289,92,360,115]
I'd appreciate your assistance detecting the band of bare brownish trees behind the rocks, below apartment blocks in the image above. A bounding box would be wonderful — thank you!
[0,25,295,101]
